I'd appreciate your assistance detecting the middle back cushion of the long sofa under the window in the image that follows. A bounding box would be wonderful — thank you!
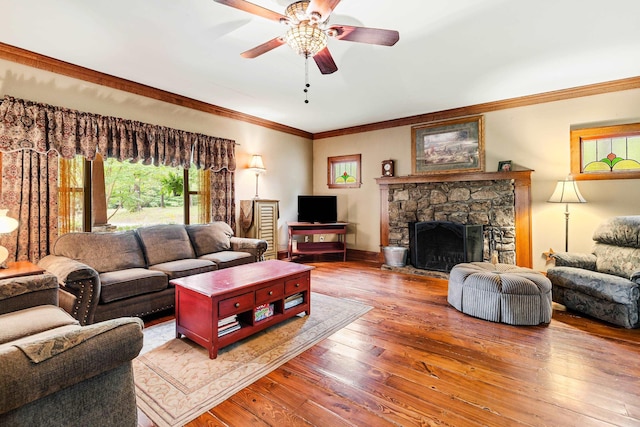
[136,224,195,265]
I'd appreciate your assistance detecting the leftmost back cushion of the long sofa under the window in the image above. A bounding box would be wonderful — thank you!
[53,230,145,273]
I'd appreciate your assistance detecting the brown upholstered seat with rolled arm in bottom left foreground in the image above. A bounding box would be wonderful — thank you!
[0,273,143,427]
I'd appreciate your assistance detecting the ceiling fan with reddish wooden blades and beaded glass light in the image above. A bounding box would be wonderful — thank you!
[215,0,400,74]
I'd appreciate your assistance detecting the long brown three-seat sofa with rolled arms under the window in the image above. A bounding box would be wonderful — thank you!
[38,222,267,325]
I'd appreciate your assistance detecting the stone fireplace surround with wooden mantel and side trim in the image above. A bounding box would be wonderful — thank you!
[376,170,532,267]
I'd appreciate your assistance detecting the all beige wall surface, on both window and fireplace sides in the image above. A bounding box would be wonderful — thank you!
[0,56,640,270]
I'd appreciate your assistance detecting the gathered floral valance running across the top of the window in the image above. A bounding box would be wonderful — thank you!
[0,95,236,171]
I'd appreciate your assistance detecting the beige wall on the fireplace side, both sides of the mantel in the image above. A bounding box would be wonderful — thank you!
[313,90,640,270]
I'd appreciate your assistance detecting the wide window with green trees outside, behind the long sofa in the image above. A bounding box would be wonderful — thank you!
[58,156,210,234]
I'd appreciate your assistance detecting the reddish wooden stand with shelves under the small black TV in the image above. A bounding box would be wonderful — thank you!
[287,222,349,261]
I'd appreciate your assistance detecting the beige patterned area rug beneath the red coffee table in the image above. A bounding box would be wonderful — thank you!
[133,292,371,427]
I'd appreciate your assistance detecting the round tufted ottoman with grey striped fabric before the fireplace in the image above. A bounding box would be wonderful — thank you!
[447,262,552,325]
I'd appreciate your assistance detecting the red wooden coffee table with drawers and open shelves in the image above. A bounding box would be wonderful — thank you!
[171,260,313,359]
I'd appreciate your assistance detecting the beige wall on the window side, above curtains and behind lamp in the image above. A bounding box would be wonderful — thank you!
[0,60,312,248]
